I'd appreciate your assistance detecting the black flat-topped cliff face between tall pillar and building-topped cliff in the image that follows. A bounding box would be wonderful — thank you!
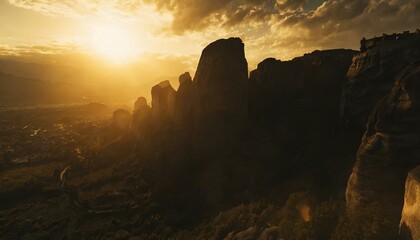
[249,49,356,152]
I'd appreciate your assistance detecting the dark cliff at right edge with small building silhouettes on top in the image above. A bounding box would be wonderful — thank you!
[341,32,420,134]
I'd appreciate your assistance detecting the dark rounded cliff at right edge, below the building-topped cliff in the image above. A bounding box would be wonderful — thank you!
[346,63,420,223]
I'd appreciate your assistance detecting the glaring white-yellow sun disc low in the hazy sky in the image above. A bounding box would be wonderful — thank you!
[91,25,137,63]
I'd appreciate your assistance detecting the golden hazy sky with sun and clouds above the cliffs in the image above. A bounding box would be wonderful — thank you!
[0,0,420,80]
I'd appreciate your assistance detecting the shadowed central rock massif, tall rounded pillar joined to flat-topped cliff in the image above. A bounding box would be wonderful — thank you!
[131,38,356,214]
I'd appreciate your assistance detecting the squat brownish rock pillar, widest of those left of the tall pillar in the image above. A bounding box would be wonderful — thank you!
[152,80,175,120]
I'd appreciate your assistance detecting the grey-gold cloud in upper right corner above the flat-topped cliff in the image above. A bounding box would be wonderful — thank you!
[273,0,420,48]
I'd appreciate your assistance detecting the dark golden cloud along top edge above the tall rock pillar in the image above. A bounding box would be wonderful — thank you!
[146,0,306,33]
